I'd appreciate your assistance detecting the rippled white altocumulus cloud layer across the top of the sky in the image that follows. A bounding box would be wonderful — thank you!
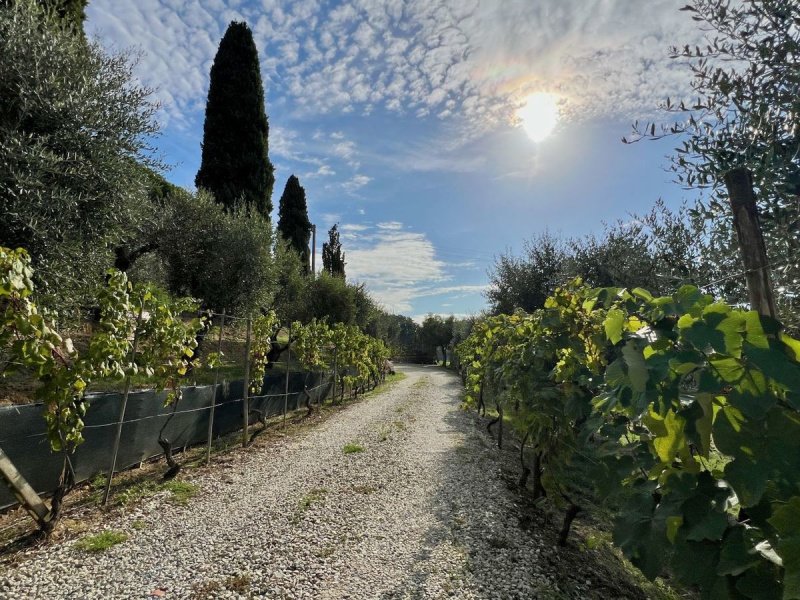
[89,0,698,130]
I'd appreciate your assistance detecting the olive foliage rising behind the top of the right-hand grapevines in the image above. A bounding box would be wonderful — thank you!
[487,200,728,314]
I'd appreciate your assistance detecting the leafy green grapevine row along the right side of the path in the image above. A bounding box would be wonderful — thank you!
[458,282,800,598]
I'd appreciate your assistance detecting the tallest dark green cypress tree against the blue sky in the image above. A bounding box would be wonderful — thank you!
[195,21,275,219]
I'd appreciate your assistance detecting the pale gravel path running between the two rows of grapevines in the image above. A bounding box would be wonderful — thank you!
[0,366,587,600]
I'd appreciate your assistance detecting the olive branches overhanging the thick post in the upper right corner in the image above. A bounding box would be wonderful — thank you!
[625,0,800,317]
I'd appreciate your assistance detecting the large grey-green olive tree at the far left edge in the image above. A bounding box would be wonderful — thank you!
[0,0,160,316]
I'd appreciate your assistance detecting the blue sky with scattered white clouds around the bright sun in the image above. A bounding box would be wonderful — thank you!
[86,0,700,319]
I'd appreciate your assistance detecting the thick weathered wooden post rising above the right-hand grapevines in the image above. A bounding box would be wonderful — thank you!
[725,168,777,319]
